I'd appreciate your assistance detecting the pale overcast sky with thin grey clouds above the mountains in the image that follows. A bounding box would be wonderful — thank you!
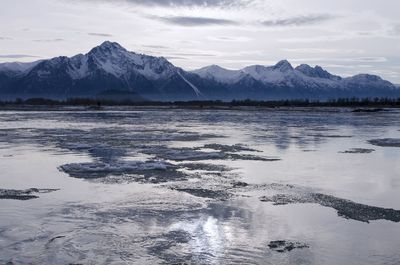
[0,0,400,84]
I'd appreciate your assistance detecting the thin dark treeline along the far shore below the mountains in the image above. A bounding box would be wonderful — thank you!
[0,98,400,108]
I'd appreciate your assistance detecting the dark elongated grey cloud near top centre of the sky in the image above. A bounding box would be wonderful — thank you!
[152,16,237,27]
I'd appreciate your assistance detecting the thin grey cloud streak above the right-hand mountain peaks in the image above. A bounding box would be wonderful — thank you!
[261,14,336,27]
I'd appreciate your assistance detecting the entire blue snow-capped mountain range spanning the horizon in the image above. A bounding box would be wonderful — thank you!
[0,41,400,100]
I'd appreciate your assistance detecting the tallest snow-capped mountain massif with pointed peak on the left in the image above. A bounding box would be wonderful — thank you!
[0,41,205,100]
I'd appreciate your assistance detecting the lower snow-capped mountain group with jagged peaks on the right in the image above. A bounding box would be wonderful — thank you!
[193,60,399,98]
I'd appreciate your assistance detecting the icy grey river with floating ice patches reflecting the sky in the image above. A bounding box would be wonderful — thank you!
[0,109,400,265]
